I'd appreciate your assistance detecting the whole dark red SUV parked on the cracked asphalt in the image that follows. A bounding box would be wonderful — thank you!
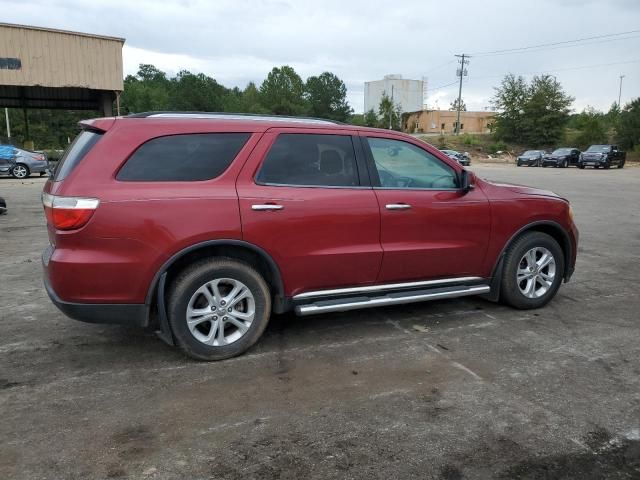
[43,113,578,360]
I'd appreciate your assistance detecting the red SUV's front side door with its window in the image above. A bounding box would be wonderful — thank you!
[365,136,490,283]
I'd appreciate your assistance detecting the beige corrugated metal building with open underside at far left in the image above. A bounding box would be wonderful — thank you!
[0,23,124,115]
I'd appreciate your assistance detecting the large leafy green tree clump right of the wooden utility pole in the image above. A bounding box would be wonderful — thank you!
[492,74,574,146]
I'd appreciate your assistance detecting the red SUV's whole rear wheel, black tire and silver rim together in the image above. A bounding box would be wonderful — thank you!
[168,258,271,360]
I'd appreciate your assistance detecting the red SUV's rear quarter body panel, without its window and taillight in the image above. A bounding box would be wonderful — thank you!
[45,119,262,303]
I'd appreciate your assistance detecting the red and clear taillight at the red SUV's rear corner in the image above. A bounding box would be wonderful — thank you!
[42,193,100,230]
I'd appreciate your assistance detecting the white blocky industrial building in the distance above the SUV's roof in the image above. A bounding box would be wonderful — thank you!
[364,75,425,113]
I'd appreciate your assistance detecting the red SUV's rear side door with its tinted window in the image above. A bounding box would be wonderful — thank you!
[237,129,382,295]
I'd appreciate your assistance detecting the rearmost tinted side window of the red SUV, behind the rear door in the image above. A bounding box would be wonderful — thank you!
[117,133,251,182]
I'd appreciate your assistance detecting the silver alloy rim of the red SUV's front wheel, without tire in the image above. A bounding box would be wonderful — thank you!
[516,247,556,298]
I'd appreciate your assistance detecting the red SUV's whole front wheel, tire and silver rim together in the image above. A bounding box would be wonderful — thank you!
[501,232,564,309]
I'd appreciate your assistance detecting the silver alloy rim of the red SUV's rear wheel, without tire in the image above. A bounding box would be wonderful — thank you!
[186,278,256,347]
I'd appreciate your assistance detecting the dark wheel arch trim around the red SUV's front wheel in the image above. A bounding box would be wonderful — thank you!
[488,220,573,301]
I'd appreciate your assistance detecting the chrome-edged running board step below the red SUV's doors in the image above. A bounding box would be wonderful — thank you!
[294,284,491,315]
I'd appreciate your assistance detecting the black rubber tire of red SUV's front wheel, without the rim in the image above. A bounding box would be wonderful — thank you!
[500,232,564,310]
